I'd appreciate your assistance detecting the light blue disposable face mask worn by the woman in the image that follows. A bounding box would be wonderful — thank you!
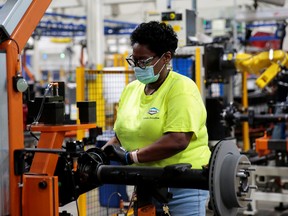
[134,56,165,85]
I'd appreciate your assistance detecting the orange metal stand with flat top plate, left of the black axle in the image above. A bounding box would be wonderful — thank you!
[22,124,96,216]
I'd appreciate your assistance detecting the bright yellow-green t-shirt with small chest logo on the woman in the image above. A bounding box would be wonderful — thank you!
[114,71,210,168]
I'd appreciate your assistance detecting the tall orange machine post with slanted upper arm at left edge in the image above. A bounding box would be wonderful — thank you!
[0,0,67,216]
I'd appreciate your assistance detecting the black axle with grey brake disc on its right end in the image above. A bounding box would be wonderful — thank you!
[78,140,256,216]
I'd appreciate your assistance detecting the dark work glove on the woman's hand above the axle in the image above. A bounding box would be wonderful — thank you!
[103,144,133,165]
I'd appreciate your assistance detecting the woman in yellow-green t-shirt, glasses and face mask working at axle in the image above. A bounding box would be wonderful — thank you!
[103,21,210,216]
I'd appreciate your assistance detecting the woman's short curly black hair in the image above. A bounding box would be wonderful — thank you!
[130,21,178,56]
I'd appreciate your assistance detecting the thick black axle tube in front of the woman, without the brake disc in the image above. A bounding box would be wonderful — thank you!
[97,165,209,190]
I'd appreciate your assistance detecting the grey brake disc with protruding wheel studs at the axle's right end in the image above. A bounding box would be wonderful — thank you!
[209,140,254,216]
